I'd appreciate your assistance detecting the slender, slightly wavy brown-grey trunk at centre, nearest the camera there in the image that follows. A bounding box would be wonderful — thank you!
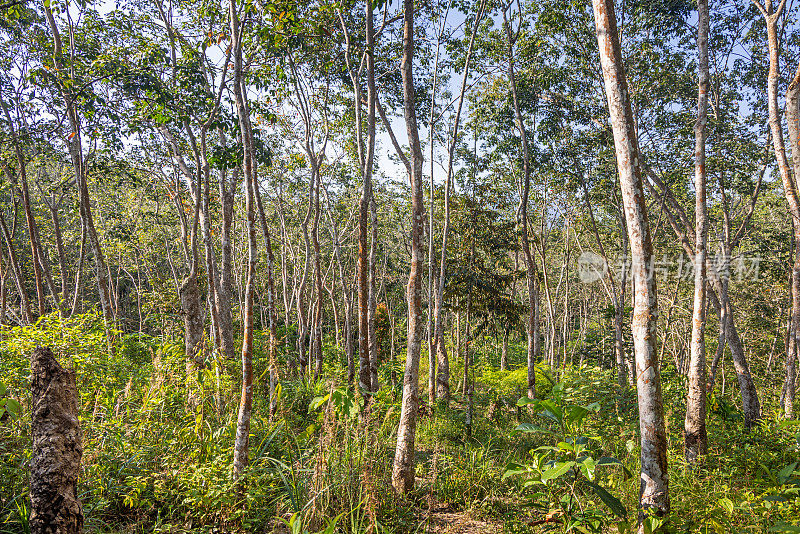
[392,0,425,493]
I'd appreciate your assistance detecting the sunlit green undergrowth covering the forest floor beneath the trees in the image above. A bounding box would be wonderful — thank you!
[0,323,800,534]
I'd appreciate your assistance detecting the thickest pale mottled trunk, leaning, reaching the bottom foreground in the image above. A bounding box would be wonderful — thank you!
[592,0,669,532]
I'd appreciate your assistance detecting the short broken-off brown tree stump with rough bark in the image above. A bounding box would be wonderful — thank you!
[30,347,83,534]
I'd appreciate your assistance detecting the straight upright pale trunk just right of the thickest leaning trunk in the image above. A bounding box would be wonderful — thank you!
[684,0,709,462]
